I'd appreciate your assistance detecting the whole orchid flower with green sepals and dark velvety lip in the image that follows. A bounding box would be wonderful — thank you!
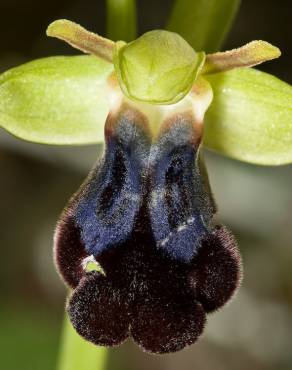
[0,0,292,353]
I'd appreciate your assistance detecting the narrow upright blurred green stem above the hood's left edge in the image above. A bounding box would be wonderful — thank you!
[106,0,136,41]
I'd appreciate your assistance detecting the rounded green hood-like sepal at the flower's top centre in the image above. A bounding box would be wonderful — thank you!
[114,30,205,104]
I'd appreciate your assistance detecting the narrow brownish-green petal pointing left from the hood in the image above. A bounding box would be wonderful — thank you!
[47,19,114,62]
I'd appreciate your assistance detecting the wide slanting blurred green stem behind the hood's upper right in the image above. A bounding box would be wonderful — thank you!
[166,0,240,53]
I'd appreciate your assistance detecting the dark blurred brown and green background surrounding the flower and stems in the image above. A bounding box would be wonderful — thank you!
[0,0,292,370]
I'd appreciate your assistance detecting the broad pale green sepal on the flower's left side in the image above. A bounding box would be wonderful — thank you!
[0,56,113,144]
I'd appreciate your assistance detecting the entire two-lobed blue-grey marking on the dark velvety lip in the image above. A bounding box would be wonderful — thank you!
[76,109,211,262]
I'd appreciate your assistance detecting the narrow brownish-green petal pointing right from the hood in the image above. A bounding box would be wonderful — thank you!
[202,40,281,73]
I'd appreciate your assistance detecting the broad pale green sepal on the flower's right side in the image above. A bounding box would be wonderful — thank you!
[204,68,292,165]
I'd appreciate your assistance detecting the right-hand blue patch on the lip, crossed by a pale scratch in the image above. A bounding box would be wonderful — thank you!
[150,145,208,262]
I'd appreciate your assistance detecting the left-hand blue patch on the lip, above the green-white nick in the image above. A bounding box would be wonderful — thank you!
[76,142,141,255]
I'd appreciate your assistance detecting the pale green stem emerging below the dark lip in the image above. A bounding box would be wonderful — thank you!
[57,317,108,370]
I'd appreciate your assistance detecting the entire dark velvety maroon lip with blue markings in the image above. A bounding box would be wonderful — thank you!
[55,105,240,353]
